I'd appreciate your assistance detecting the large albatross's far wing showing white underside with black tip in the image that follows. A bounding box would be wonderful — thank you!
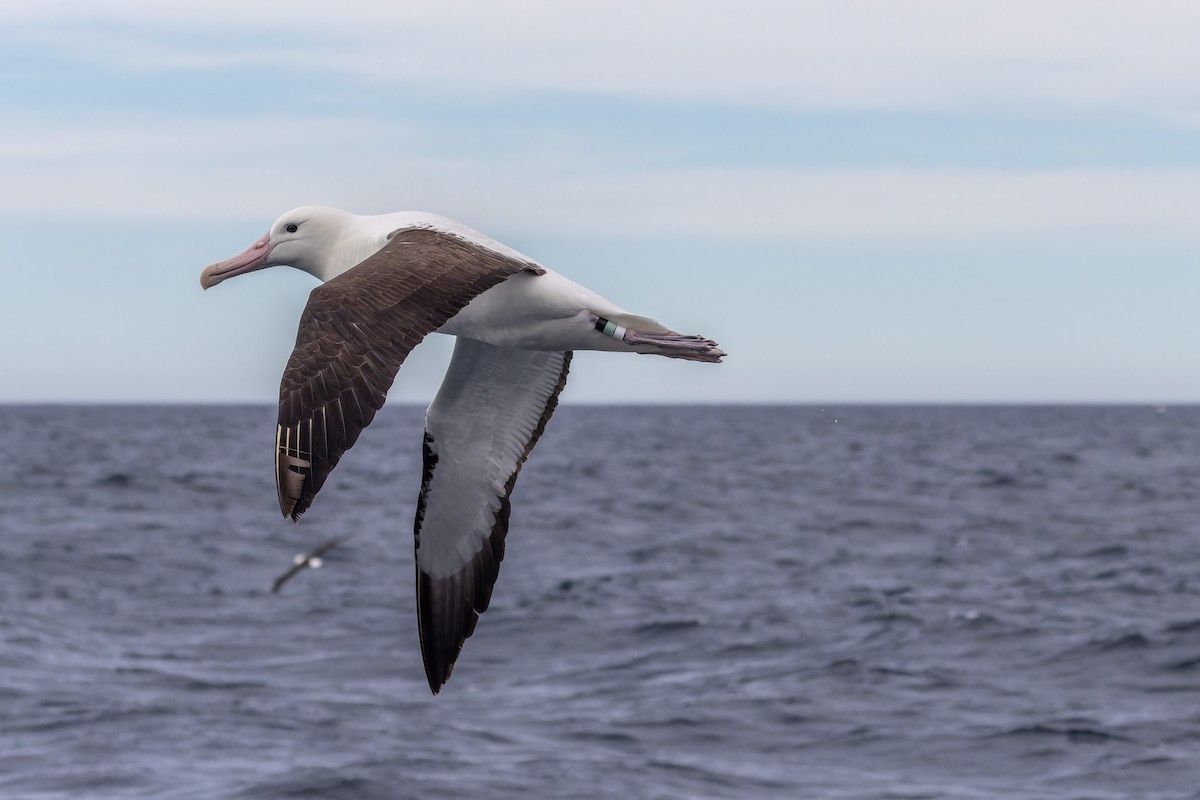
[414,338,571,694]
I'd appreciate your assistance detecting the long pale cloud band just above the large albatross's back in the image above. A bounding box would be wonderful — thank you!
[0,118,1200,242]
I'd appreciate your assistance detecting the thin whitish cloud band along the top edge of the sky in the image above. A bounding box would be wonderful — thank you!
[14,0,1200,114]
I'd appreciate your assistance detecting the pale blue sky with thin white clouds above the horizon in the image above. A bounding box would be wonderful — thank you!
[0,0,1200,403]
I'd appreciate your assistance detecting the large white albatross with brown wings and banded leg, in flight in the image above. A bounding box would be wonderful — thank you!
[200,206,725,694]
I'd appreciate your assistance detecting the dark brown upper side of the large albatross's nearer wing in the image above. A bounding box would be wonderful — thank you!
[275,228,544,521]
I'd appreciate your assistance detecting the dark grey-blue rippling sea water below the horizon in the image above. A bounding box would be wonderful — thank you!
[0,407,1200,800]
